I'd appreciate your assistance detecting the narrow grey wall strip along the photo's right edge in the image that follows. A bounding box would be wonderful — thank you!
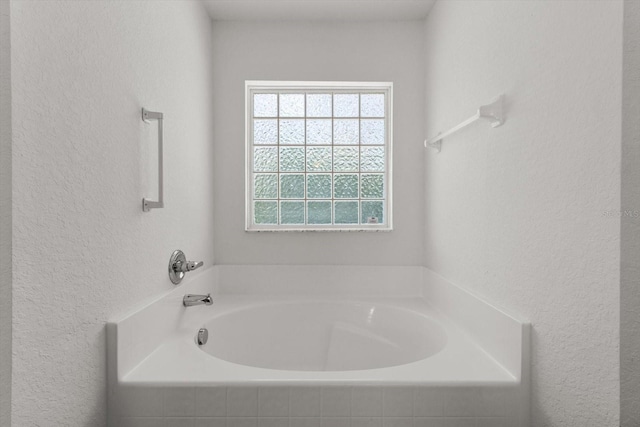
[620,0,640,427]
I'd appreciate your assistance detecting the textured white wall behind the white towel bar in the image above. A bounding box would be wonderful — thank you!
[425,1,622,427]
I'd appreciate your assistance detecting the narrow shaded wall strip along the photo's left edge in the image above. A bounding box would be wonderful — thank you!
[0,1,11,426]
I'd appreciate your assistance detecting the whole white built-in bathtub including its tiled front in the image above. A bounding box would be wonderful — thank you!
[107,266,528,427]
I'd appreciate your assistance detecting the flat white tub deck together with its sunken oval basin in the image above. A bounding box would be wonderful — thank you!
[120,295,517,385]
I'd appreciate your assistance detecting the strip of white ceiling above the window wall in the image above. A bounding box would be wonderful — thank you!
[202,0,436,21]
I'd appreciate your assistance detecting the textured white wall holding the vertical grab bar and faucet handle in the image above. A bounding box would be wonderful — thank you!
[11,0,214,427]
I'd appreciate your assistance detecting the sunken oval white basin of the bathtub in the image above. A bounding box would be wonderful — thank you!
[200,301,447,371]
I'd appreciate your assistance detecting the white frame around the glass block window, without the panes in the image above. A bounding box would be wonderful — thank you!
[245,80,393,232]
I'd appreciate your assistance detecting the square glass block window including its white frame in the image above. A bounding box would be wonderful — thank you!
[246,82,392,231]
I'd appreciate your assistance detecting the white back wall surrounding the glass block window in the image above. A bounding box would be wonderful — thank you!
[213,21,424,265]
